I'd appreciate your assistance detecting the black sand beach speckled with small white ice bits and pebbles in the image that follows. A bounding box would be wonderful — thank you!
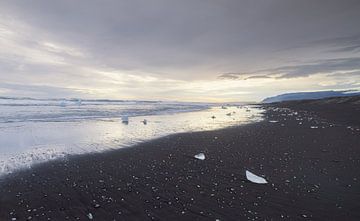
[0,97,360,220]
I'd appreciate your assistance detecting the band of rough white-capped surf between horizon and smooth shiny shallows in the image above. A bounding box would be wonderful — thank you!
[0,98,211,123]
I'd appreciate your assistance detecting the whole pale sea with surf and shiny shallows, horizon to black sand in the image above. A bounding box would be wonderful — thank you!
[0,98,262,176]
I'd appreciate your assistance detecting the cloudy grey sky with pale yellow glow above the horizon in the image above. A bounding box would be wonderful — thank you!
[0,0,360,102]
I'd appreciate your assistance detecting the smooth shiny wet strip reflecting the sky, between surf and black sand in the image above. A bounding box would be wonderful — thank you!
[0,107,262,177]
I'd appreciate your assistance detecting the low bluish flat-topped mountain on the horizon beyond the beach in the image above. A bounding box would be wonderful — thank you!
[262,90,360,103]
